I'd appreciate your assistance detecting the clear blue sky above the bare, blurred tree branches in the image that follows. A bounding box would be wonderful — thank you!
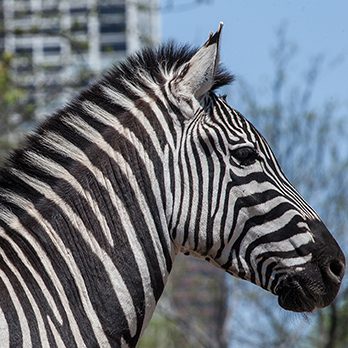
[161,0,348,109]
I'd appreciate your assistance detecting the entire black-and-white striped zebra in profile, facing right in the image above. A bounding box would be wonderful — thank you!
[0,24,345,347]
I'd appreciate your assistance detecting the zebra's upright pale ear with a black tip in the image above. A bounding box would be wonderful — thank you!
[175,22,223,99]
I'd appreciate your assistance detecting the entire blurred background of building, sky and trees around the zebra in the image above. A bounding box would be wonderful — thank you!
[0,0,348,348]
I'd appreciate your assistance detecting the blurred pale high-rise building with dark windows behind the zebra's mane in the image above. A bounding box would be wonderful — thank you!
[0,0,159,117]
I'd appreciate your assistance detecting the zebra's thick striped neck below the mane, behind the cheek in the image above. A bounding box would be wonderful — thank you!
[0,99,174,347]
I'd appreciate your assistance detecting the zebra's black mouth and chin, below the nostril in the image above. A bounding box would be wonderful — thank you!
[276,279,323,312]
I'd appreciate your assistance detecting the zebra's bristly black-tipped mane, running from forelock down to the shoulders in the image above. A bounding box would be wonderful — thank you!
[0,42,234,186]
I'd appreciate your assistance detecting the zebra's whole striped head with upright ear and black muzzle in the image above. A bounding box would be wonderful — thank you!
[166,25,345,311]
